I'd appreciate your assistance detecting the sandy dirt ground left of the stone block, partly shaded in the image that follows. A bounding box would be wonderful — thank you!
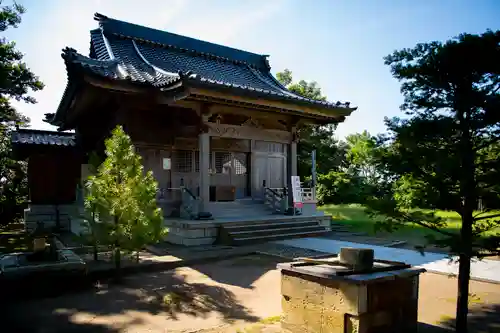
[0,255,281,333]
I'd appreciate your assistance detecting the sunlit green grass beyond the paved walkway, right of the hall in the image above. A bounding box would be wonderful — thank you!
[320,204,500,244]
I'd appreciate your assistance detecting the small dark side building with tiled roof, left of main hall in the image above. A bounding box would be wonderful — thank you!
[12,129,84,231]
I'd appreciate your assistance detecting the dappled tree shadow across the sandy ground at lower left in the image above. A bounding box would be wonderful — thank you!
[0,271,259,333]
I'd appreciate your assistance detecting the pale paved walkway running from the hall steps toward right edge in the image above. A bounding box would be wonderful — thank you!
[273,237,500,283]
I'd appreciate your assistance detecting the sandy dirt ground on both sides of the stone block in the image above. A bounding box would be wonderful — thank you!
[0,255,500,333]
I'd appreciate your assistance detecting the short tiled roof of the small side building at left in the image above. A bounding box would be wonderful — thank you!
[12,129,76,147]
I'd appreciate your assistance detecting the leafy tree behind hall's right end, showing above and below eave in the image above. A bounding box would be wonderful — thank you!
[276,69,345,178]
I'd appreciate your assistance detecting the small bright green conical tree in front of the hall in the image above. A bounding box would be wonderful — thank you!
[85,126,166,274]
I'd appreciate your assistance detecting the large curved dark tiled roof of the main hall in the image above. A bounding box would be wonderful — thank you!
[63,14,349,108]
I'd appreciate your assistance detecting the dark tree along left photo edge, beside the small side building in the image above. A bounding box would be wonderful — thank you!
[0,1,43,223]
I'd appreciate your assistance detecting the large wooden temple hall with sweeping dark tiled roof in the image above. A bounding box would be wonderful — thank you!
[12,14,356,245]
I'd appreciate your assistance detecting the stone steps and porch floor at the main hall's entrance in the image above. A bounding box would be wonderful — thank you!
[211,199,330,245]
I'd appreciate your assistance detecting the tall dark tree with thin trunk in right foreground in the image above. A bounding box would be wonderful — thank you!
[370,31,500,332]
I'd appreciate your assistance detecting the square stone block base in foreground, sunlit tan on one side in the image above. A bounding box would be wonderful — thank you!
[278,263,424,333]
